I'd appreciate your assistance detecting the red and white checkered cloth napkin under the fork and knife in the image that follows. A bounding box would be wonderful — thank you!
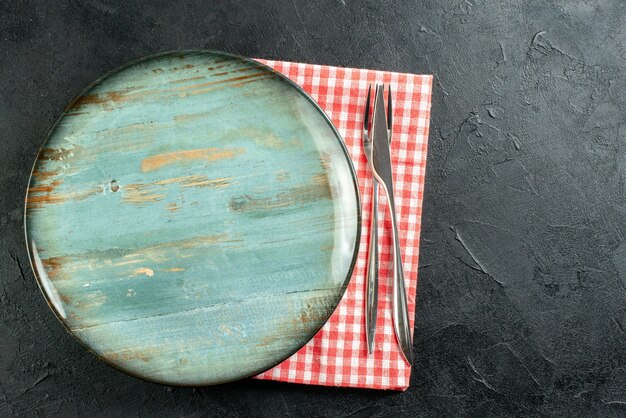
[251,60,432,390]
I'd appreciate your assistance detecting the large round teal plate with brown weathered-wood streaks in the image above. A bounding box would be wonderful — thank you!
[24,51,360,385]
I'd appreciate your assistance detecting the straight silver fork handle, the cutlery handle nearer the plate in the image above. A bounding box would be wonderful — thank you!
[365,178,378,354]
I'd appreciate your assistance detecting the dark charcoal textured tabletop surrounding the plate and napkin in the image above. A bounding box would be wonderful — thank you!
[0,0,626,416]
